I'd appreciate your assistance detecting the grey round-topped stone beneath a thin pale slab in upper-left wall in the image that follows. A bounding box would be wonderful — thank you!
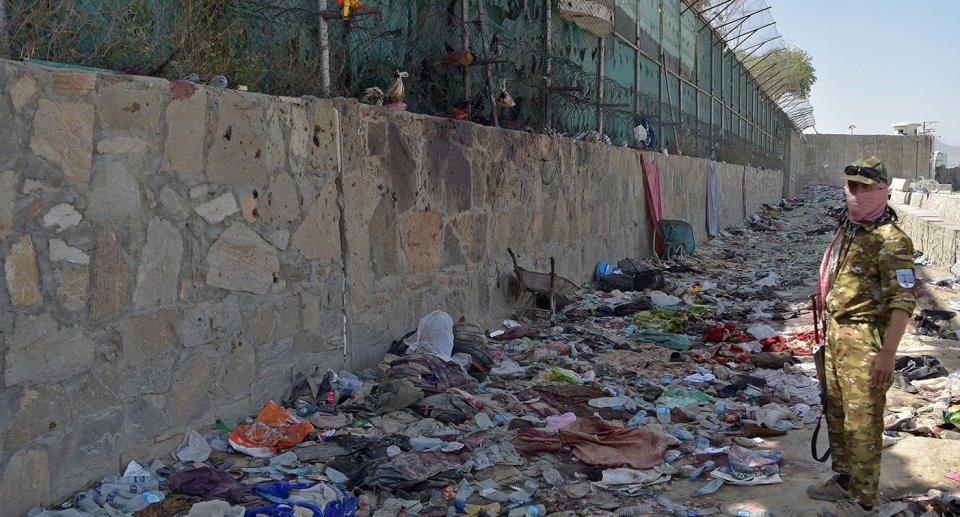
[86,162,141,224]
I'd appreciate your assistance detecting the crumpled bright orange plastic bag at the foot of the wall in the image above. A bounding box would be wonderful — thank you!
[227,401,313,458]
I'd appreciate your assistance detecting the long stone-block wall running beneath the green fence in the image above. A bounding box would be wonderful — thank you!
[0,57,782,515]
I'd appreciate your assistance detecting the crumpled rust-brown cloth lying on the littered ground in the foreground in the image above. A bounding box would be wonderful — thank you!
[558,416,667,469]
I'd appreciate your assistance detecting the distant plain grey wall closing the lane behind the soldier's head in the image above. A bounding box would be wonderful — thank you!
[791,135,933,187]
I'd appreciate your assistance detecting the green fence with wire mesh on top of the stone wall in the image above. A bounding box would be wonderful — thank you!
[7,0,790,168]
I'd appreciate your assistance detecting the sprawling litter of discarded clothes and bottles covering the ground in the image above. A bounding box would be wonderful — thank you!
[30,187,960,517]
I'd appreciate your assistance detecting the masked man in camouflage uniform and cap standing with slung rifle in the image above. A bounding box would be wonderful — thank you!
[807,156,916,516]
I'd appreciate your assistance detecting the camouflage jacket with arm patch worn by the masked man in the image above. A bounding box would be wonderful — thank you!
[826,220,917,322]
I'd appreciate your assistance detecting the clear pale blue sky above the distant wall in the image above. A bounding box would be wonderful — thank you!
[768,0,960,145]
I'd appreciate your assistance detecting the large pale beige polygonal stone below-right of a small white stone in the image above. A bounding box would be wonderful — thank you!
[207,223,280,294]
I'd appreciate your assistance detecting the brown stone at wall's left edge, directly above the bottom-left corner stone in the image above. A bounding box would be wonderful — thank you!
[5,384,70,450]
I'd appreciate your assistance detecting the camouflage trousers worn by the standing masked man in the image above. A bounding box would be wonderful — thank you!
[824,318,892,505]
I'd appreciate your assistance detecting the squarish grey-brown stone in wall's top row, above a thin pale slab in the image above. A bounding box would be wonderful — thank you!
[97,82,160,135]
